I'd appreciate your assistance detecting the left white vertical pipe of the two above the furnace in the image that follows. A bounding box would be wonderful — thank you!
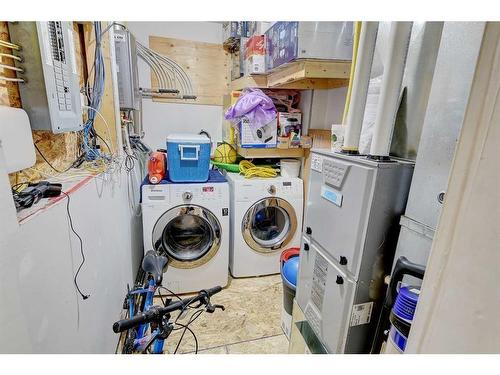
[342,22,378,153]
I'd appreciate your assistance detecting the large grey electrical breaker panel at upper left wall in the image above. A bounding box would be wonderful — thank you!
[9,21,83,133]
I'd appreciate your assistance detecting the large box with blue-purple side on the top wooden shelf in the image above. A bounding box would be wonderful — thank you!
[266,22,354,71]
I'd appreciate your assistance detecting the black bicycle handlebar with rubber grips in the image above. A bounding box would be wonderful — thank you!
[113,286,222,333]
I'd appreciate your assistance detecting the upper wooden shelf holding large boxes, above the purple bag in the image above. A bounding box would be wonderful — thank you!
[231,60,351,90]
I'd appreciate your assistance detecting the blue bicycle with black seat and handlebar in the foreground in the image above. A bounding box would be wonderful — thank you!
[113,250,224,354]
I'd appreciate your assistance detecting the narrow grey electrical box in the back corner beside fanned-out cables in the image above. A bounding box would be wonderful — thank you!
[114,26,141,111]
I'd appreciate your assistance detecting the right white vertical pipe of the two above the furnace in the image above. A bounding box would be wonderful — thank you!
[370,22,413,158]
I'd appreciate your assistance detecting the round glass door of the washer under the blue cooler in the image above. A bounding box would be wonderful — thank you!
[152,205,222,268]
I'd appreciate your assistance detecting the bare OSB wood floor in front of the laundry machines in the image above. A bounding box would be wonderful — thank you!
[155,275,288,354]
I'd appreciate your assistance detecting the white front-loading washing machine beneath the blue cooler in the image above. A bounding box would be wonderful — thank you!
[141,171,229,293]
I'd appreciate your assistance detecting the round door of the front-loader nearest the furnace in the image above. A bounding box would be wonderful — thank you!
[241,198,297,253]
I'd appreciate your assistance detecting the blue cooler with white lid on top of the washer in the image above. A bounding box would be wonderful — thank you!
[167,133,211,182]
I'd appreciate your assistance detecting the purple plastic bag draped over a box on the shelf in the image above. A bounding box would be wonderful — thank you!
[224,89,276,128]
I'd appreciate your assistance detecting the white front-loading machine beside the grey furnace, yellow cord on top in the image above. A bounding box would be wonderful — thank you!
[226,173,304,277]
